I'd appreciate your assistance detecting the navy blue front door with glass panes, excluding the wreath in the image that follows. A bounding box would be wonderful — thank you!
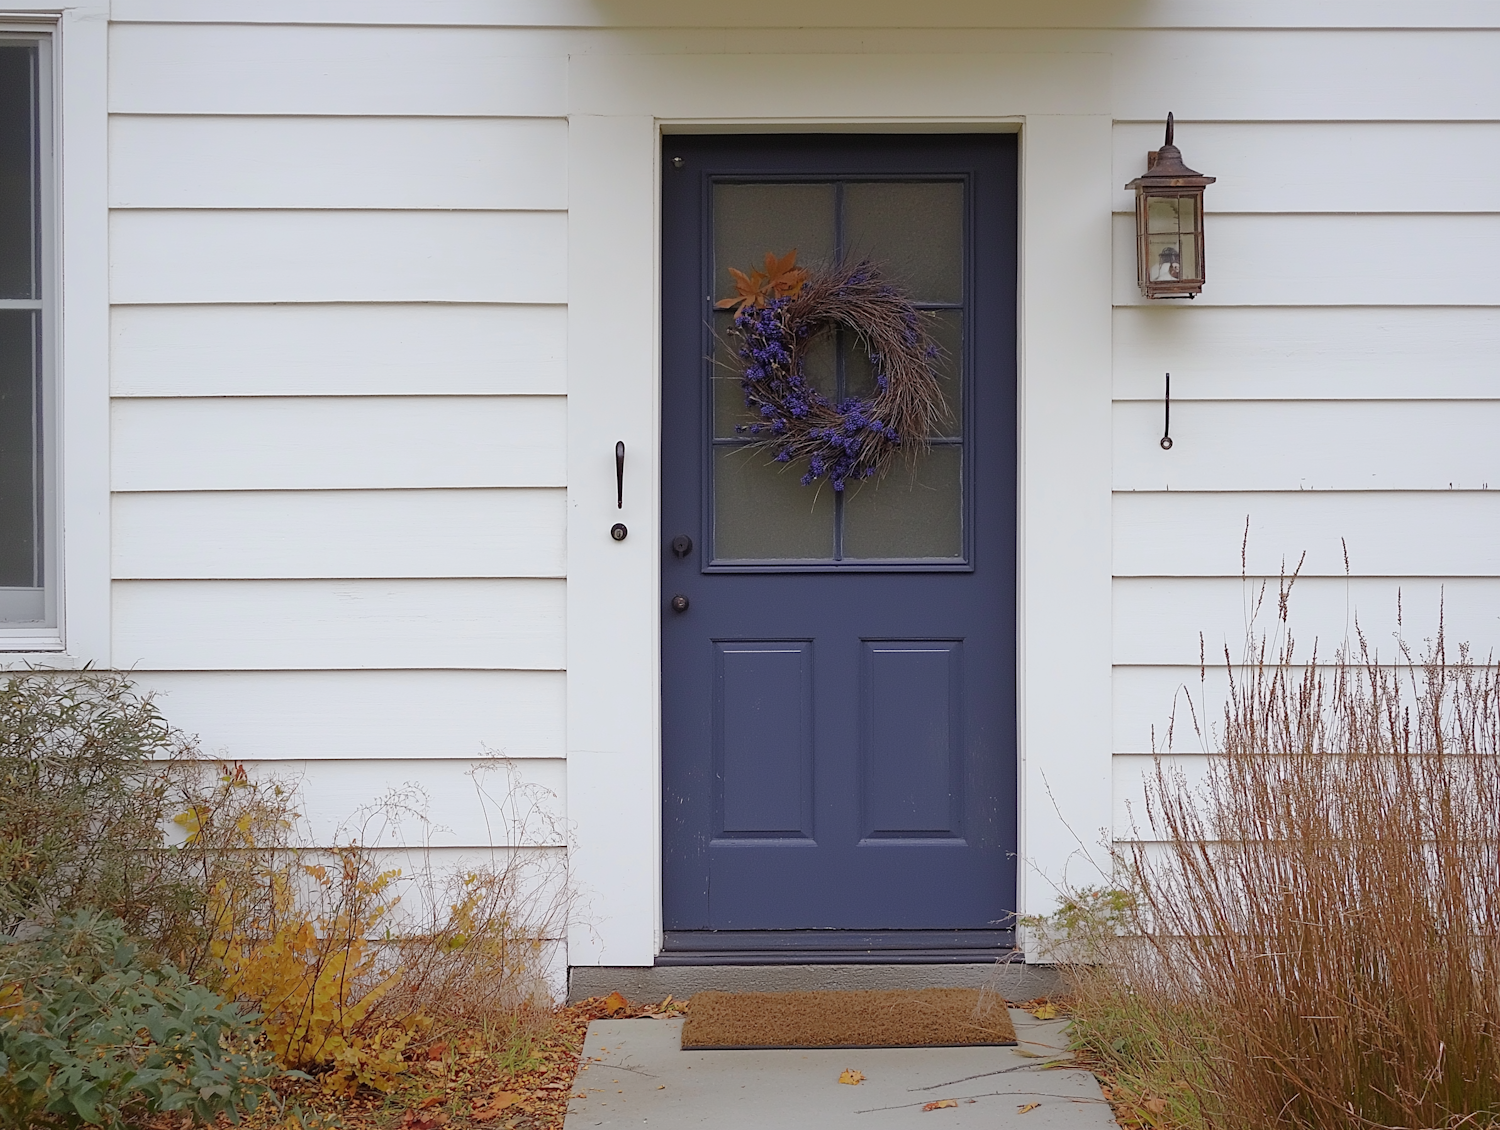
[662,135,1017,960]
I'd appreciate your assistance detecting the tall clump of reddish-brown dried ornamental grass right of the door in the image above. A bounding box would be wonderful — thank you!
[1104,578,1500,1130]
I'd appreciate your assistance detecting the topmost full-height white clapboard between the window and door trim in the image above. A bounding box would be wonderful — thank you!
[110,24,567,117]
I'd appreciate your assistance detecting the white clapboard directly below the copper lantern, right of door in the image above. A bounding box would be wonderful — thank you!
[1115,304,1500,401]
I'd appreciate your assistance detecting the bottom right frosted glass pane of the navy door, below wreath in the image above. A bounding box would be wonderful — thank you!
[843,444,963,560]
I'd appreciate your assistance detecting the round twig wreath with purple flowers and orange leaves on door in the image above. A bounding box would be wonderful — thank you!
[719,248,950,491]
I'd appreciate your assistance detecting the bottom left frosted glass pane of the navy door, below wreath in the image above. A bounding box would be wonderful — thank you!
[714,444,834,561]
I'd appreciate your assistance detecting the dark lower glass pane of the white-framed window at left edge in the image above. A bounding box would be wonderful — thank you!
[0,311,42,585]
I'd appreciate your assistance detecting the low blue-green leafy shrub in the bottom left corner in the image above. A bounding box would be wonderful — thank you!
[0,914,276,1127]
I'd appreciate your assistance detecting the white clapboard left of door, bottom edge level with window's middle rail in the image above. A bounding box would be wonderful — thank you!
[110,209,567,303]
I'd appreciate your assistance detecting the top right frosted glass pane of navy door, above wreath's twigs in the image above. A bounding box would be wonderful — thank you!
[843,180,963,302]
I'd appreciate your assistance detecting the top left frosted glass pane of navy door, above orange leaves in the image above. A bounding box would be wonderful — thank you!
[714,185,834,299]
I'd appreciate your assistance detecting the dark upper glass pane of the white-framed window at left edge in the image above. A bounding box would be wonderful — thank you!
[0,44,41,299]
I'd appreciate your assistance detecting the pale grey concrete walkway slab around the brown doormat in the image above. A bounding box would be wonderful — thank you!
[564,1008,1115,1130]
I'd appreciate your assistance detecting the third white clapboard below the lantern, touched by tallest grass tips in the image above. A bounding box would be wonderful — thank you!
[1115,483,1500,576]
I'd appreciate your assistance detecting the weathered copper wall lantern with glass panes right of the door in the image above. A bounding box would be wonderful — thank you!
[1125,114,1215,299]
